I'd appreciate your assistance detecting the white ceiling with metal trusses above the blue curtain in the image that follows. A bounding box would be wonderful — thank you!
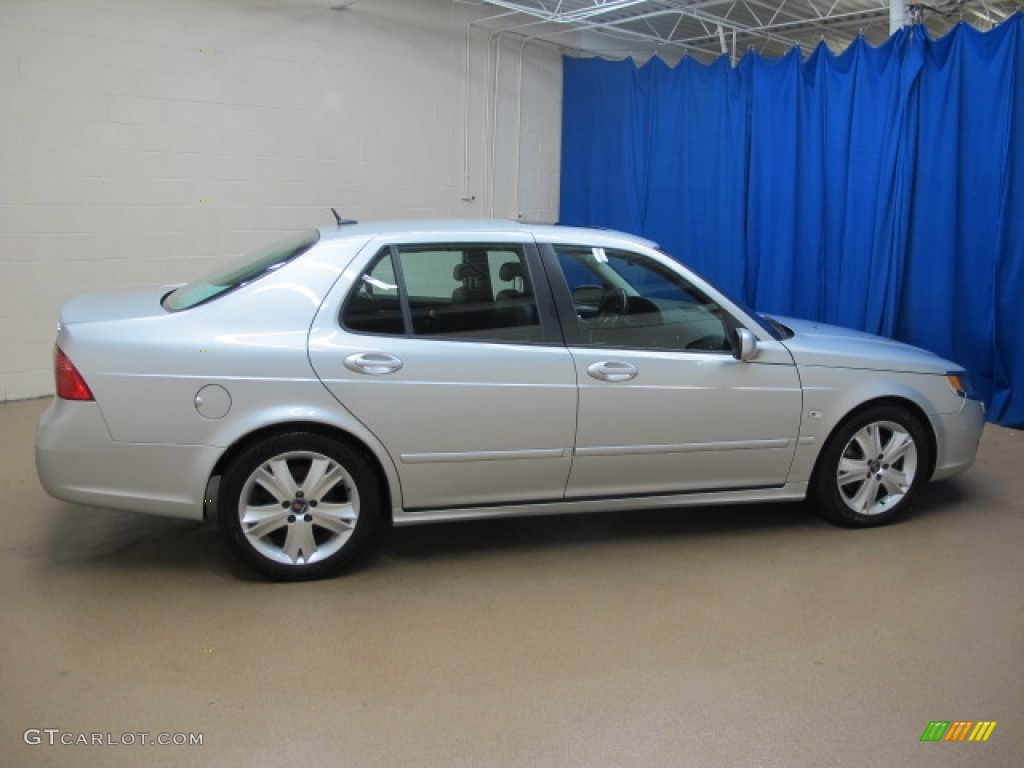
[458,0,1024,61]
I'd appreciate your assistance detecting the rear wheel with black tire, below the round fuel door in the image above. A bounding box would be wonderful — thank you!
[217,432,381,582]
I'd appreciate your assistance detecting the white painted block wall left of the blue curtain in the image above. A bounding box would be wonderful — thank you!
[0,0,561,400]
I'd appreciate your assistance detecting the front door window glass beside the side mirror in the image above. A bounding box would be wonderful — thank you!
[554,246,735,351]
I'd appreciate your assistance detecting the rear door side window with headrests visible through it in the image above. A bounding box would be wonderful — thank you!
[341,245,542,342]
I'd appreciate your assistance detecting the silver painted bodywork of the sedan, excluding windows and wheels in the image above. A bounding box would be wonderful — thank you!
[37,221,984,524]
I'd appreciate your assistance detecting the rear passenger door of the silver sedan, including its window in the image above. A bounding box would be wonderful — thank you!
[309,236,577,510]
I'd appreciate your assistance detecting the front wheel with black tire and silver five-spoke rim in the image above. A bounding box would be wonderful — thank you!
[808,406,932,527]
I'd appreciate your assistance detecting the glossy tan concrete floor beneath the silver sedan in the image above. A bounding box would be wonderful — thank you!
[0,400,1024,768]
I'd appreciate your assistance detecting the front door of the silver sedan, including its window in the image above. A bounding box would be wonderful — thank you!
[548,246,802,498]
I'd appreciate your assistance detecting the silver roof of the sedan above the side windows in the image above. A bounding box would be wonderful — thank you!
[319,219,657,248]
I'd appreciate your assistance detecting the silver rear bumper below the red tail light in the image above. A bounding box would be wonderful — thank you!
[36,398,219,520]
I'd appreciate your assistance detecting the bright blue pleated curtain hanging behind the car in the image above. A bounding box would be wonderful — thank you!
[561,14,1024,426]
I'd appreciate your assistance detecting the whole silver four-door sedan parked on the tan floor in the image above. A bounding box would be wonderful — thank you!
[36,221,984,580]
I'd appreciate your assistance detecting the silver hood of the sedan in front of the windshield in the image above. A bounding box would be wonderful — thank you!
[773,315,962,374]
